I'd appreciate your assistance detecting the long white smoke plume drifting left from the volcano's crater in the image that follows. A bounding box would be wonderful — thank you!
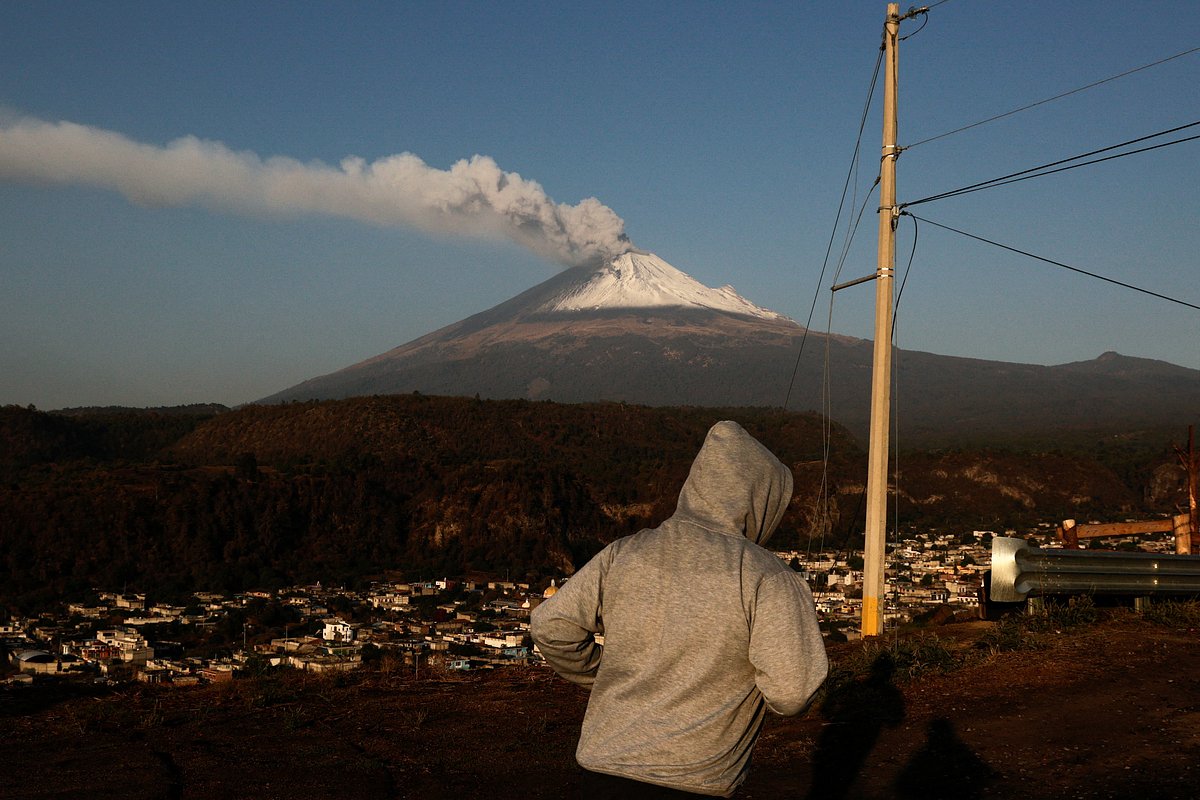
[0,116,632,266]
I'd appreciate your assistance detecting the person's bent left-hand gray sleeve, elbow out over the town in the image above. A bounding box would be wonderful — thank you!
[529,547,611,687]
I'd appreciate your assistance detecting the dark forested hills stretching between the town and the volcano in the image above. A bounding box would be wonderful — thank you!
[0,395,1175,606]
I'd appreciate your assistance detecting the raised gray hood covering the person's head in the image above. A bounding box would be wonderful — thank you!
[676,420,792,545]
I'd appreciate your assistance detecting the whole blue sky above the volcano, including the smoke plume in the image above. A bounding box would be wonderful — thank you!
[0,0,1200,409]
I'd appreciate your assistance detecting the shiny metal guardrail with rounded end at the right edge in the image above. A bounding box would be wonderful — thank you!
[990,536,1200,603]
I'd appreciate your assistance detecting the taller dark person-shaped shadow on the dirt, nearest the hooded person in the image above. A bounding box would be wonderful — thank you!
[809,652,905,800]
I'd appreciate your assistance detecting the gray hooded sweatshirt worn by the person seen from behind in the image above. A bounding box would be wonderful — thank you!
[530,421,828,796]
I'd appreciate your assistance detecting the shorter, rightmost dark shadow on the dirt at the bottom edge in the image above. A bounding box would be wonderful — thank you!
[895,717,996,800]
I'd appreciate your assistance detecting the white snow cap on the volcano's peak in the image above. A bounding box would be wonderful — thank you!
[539,251,786,319]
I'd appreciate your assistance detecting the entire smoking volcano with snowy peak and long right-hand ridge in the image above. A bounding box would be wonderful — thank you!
[259,251,1200,445]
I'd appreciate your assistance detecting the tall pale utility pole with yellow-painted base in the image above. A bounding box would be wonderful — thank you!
[862,2,900,636]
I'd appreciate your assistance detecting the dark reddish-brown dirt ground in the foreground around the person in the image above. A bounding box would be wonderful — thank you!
[0,614,1200,800]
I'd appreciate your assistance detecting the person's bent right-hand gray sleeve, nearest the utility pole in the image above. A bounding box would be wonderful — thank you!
[750,572,829,716]
